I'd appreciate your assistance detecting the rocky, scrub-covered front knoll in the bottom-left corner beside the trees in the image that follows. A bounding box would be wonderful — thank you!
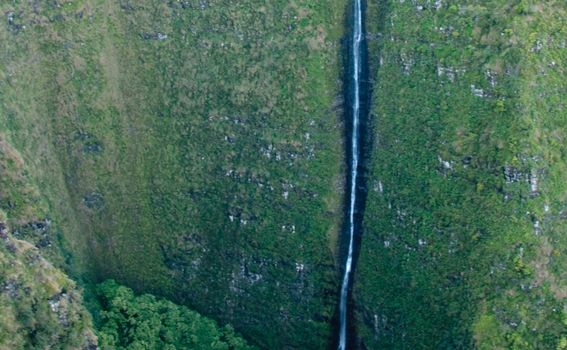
[0,231,97,350]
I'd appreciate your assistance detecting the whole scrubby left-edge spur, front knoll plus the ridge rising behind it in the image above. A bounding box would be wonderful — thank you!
[0,134,97,350]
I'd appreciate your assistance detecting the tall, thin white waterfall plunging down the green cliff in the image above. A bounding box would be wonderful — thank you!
[338,0,362,350]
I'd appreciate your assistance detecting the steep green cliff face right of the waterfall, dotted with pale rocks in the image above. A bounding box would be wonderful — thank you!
[355,0,567,349]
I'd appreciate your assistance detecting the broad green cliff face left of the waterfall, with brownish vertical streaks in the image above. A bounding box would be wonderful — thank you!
[0,0,345,348]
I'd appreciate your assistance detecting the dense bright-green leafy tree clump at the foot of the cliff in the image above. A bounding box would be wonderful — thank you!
[96,280,253,350]
